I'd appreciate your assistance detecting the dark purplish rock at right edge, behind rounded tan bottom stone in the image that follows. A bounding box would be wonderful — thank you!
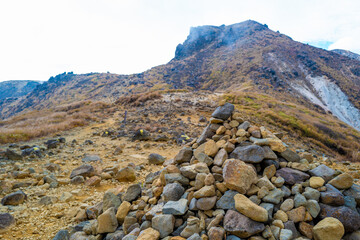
[319,203,360,233]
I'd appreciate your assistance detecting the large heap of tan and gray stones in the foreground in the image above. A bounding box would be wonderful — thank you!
[54,103,360,240]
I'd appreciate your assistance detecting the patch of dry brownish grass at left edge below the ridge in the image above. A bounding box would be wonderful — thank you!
[0,101,113,144]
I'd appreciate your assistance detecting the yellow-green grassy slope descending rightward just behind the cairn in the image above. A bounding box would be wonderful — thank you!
[221,91,360,161]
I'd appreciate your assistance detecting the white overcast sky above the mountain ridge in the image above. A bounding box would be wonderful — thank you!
[0,0,360,81]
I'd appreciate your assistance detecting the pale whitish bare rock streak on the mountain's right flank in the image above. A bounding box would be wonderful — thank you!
[292,76,360,131]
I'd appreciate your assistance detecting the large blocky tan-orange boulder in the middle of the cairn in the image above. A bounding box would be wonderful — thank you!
[223,159,257,194]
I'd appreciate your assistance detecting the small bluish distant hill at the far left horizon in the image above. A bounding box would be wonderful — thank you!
[0,80,41,100]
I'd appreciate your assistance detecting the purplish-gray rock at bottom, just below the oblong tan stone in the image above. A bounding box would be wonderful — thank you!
[224,210,265,238]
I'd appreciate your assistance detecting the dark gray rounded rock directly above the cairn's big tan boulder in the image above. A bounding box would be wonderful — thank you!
[230,145,265,163]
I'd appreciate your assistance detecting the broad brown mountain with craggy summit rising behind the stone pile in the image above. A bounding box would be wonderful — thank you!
[0,20,360,132]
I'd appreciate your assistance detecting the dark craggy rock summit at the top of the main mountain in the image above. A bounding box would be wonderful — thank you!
[175,20,268,59]
